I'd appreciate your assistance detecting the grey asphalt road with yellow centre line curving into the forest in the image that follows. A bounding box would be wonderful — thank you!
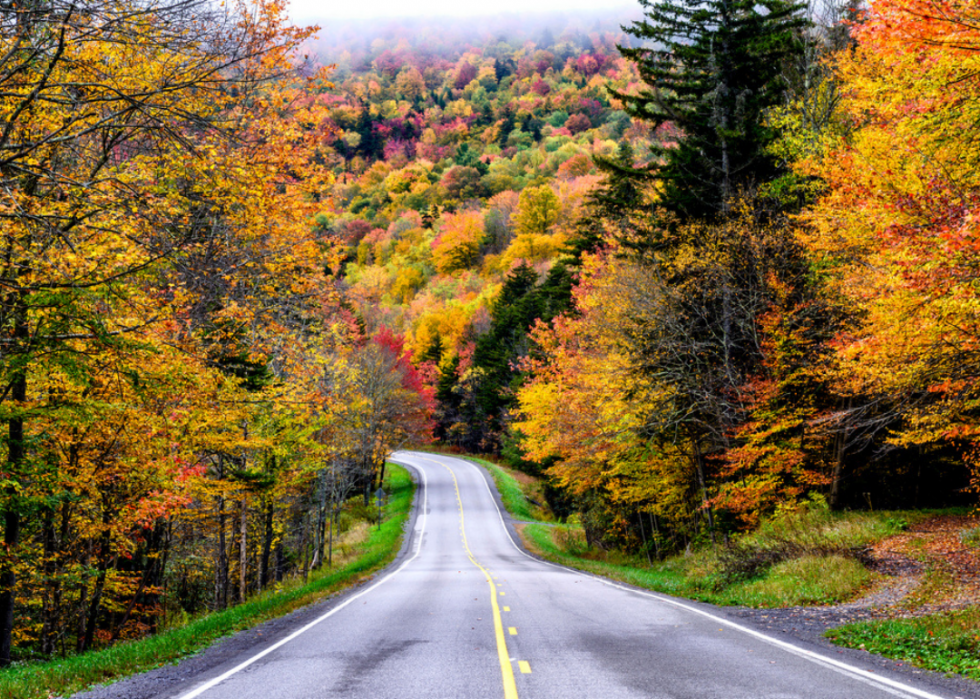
[170,452,950,699]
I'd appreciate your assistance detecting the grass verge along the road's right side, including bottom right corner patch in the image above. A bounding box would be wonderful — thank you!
[470,457,980,680]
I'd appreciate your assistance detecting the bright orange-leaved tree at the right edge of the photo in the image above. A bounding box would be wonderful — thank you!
[798,0,980,500]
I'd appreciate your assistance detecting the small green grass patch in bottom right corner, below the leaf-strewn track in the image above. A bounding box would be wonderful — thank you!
[826,607,980,680]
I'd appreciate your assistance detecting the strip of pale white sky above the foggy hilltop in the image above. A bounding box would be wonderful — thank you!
[289,0,635,20]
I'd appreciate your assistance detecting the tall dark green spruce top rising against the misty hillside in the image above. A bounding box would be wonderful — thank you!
[616,0,807,219]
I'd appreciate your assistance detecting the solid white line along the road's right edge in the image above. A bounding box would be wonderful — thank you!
[449,457,956,699]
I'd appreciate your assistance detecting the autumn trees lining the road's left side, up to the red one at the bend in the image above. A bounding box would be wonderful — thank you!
[0,2,430,664]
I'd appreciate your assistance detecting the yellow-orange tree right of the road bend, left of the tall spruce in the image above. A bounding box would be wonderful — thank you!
[514,254,699,552]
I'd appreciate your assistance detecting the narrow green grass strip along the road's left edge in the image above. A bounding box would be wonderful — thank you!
[0,464,415,699]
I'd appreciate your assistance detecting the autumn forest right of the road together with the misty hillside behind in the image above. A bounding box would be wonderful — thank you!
[310,0,980,553]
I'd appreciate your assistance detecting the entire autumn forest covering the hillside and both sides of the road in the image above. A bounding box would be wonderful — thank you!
[0,0,980,676]
